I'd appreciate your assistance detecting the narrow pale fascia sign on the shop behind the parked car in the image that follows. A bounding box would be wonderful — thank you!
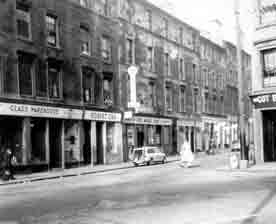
[124,117,172,126]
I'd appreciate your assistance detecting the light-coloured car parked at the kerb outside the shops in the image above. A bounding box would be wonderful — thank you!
[132,146,167,166]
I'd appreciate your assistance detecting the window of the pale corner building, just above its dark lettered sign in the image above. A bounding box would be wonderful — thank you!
[262,49,276,87]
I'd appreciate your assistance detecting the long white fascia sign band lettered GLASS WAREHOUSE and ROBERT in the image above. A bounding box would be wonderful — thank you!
[0,103,121,122]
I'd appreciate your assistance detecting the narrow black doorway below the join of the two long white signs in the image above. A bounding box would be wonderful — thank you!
[83,121,91,165]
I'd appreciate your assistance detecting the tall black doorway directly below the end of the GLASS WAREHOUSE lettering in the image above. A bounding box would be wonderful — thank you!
[49,119,62,169]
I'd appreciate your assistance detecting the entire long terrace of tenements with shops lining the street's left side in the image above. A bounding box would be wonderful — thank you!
[0,0,250,171]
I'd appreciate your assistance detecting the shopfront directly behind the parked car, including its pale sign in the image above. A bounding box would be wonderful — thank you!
[124,116,173,161]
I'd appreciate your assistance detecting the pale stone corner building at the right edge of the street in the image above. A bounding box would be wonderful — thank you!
[251,0,276,162]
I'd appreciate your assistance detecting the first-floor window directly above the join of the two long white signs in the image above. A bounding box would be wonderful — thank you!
[82,67,95,103]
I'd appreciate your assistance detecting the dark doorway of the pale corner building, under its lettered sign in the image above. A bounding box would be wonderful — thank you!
[263,111,276,162]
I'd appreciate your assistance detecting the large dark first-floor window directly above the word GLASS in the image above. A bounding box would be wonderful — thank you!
[18,53,33,96]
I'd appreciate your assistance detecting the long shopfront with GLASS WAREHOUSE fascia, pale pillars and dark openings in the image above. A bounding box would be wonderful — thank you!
[0,103,123,172]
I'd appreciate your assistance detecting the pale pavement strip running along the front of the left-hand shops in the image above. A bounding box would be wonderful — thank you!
[0,156,179,186]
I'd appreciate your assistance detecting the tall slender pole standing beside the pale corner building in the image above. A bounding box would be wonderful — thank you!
[234,0,247,166]
